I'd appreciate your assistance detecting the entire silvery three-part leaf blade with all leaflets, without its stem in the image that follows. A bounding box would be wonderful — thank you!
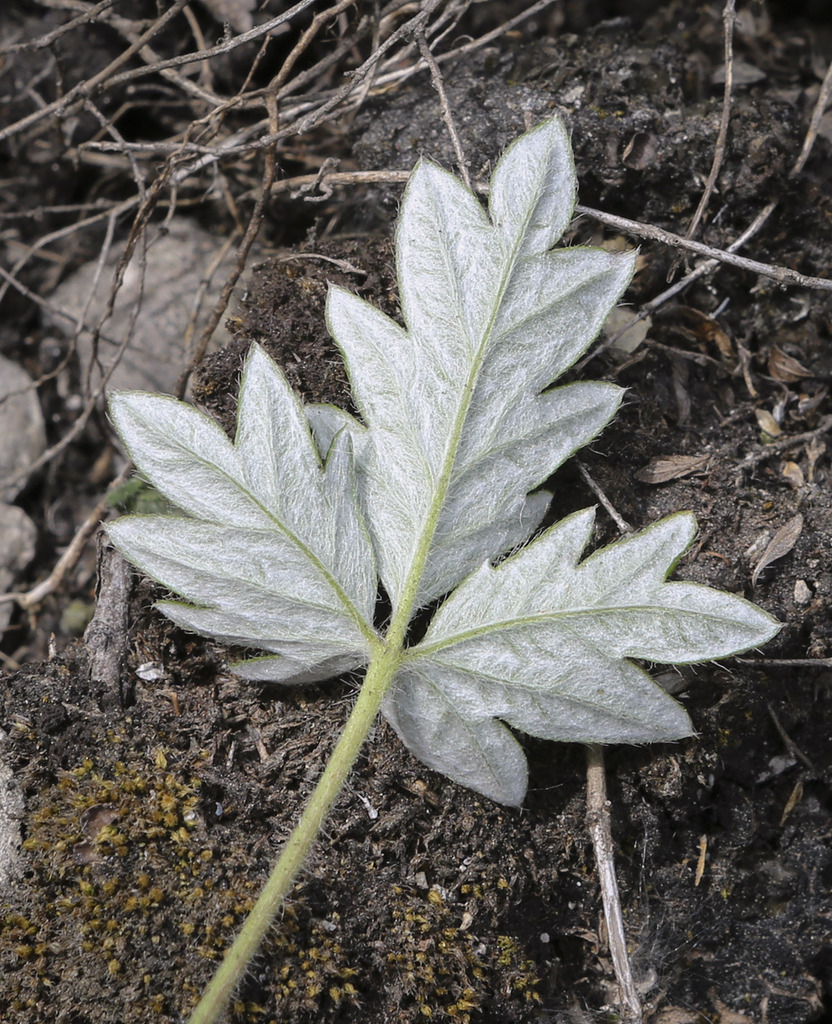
[110,120,778,804]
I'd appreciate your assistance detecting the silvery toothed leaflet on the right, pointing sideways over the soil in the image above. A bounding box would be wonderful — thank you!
[384,509,779,804]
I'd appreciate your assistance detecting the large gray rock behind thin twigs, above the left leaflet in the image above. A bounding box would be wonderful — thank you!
[47,219,253,391]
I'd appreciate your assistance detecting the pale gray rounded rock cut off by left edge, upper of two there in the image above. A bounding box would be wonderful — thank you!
[0,355,46,499]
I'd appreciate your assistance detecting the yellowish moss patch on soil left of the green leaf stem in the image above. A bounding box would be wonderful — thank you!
[0,737,270,1024]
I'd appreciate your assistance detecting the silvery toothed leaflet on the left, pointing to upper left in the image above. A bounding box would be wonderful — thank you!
[110,346,376,681]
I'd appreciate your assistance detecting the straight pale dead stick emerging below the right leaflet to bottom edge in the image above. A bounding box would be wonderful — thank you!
[586,743,643,1024]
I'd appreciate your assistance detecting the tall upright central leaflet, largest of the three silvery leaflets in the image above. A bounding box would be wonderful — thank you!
[319,120,634,610]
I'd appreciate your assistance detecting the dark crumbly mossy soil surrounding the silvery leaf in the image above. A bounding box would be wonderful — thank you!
[0,3,832,1024]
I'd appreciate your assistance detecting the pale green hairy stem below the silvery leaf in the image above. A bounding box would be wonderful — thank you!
[189,631,402,1024]
